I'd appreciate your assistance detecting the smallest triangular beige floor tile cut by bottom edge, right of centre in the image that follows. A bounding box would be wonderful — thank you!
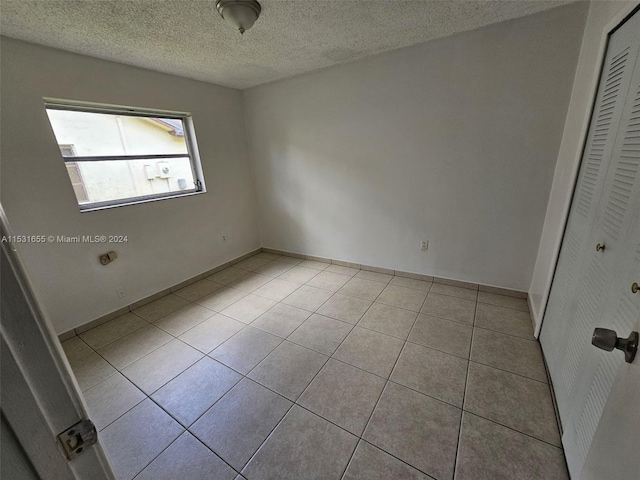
[342,440,431,480]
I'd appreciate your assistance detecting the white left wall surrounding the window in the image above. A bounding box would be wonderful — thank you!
[0,37,260,332]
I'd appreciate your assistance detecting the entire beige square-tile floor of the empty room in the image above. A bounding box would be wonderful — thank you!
[63,253,568,480]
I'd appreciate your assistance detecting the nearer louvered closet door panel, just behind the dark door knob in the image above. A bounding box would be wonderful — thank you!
[562,42,640,478]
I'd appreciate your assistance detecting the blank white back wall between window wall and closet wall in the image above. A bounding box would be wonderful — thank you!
[245,3,588,290]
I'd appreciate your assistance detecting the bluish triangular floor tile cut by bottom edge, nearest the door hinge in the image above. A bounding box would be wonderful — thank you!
[136,432,236,480]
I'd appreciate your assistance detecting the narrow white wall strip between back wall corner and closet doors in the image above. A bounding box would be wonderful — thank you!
[529,1,637,330]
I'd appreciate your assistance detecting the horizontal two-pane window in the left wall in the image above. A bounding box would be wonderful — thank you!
[45,99,205,211]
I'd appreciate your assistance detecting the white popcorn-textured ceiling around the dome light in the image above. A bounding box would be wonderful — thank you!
[0,0,570,88]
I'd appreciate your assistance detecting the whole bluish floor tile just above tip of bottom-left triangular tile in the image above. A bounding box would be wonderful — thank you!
[151,357,242,427]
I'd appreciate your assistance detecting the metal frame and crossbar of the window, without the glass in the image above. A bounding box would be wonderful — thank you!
[43,97,207,212]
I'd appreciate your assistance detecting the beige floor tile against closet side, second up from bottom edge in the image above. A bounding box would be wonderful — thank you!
[464,362,561,446]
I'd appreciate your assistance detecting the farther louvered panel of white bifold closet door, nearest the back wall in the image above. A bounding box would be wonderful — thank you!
[540,14,638,388]
